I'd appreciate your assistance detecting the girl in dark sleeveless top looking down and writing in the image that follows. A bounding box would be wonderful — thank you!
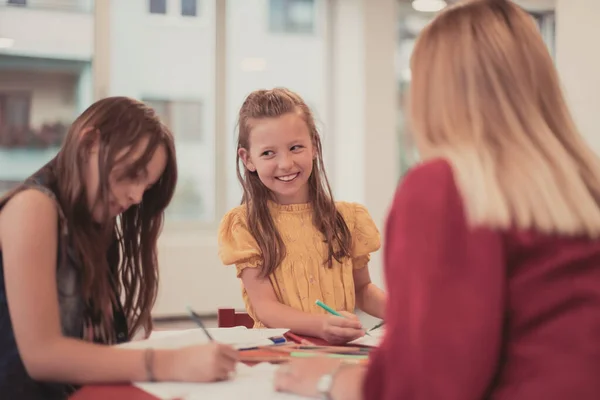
[0,97,236,399]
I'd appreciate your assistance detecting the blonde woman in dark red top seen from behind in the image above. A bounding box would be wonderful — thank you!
[276,0,600,400]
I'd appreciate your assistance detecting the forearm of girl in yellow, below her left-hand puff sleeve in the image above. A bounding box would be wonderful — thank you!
[255,301,326,337]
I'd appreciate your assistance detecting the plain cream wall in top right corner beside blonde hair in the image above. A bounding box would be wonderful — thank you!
[556,0,600,153]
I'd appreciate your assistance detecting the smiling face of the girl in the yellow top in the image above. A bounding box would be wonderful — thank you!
[239,113,316,204]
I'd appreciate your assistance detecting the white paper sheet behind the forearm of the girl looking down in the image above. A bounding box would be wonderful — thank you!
[120,326,289,349]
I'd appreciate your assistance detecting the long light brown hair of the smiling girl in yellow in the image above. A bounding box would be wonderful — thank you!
[236,88,352,277]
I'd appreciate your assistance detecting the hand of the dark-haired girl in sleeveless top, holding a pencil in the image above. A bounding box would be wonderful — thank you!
[155,343,238,382]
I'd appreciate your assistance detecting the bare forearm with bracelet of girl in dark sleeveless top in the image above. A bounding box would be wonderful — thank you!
[24,338,171,384]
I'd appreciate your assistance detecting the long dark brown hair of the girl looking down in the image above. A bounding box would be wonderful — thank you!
[53,97,177,337]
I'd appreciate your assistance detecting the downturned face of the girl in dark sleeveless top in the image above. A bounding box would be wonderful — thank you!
[86,138,167,222]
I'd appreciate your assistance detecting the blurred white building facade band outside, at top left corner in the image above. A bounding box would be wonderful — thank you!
[0,4,92,61]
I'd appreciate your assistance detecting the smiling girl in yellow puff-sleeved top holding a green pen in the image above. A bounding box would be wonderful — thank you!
[219,88,385,343]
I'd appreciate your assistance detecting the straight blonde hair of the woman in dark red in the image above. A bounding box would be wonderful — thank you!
[410,0,600,237]
